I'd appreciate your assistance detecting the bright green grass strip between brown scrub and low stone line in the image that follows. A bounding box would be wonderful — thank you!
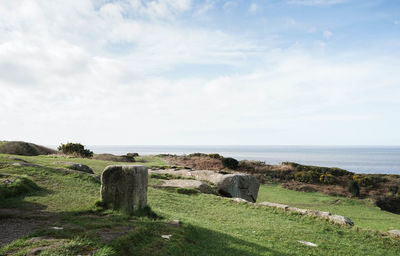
[257,185,400,231]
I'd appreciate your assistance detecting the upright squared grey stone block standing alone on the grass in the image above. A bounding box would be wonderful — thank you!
[101,165,148,213]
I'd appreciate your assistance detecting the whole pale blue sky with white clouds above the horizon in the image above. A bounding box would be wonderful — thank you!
[0,0,400,145]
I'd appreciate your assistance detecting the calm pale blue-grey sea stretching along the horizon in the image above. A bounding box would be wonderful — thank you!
[88,146,400,174]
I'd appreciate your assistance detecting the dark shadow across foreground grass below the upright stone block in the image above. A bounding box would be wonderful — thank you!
[28,206,286,256]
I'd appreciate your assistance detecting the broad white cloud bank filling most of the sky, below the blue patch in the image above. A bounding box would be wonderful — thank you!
[0,0,400,144]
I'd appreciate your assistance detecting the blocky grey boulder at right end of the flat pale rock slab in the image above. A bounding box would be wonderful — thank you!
[215,174,260,203]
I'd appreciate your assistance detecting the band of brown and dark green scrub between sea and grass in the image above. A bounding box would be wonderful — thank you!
[158,153,400,213]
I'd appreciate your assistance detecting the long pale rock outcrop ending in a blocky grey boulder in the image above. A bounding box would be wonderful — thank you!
[151,170,260,203]
